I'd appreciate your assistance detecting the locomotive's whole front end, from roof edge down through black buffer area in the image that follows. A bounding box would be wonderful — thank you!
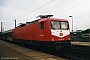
[51,19,71,50]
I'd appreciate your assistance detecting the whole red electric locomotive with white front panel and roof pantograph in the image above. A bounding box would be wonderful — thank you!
[13,15,71,49]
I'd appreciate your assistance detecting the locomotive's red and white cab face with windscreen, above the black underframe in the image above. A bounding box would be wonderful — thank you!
[51,20,70,41]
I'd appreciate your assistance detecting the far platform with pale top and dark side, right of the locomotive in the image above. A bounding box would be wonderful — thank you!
[71,42,90,55]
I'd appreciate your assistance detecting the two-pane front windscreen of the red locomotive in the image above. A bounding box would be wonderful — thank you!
[51,21,69,30]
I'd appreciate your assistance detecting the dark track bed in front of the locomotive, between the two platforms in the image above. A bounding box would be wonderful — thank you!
[36,46,90,60]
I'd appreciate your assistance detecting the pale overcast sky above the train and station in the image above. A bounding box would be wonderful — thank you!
[0,0,90,31]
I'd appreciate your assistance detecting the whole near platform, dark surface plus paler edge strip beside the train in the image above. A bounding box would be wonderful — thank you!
[0,40,67,60]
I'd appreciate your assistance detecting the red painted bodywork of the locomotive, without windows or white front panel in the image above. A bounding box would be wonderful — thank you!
[13,18,70,42]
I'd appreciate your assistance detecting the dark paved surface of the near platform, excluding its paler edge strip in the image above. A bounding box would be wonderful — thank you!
[0,40,29,60]
